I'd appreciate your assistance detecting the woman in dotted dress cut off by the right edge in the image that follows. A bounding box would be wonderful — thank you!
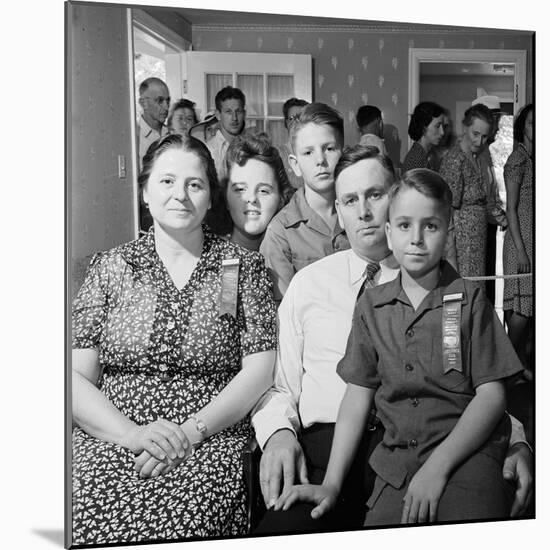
[503,104,535,379]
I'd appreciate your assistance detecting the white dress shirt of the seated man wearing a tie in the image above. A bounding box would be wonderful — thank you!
[252,249,525,449]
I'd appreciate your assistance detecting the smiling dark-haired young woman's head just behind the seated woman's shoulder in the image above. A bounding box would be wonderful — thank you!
[209,134,294,250]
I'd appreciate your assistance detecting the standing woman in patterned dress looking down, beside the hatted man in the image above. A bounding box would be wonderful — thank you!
[439,104,493,277]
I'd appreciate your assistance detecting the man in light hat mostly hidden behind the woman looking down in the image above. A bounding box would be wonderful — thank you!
[472,95,508,305]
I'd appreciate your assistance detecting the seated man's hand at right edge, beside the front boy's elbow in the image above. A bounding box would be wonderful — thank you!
[502,443,533,518]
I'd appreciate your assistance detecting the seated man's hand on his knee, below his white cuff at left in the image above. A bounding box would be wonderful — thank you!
[260,429,309,509]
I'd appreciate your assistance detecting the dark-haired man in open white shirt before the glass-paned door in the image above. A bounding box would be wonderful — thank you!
[206,86,246,182]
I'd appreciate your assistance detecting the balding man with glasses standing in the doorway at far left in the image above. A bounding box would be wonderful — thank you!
[138,77,170,165]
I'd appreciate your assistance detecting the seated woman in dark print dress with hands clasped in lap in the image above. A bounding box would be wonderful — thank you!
[72,135,276,545]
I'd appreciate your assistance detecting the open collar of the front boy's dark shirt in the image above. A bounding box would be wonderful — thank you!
[372,260,468,308]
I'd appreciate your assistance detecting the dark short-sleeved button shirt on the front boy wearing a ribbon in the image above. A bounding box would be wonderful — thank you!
[337,262,523,488]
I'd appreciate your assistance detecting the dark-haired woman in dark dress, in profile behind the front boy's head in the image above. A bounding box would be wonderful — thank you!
[402,101,445,172]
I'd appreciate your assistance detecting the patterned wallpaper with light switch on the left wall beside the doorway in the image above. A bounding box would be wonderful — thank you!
[67,4,138,292]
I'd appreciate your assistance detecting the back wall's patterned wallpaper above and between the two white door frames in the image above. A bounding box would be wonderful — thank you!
[193,26,532,166]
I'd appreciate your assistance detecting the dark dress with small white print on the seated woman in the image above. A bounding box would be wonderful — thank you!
[72,228,276,545]
